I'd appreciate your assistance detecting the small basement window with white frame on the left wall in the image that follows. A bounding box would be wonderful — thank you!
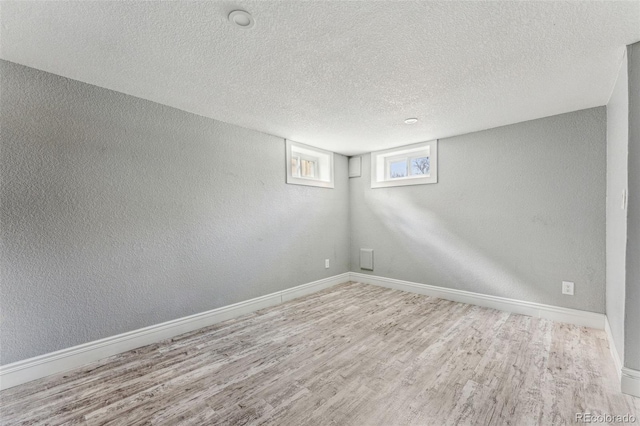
[286,140,334,188]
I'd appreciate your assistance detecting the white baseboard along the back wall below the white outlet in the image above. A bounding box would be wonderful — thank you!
[350,272,605,330]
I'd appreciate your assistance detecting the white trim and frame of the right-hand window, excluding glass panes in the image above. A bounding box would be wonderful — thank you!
[371,139,438,188]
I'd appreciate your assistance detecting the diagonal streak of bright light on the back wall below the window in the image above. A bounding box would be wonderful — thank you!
[366,191,539,300]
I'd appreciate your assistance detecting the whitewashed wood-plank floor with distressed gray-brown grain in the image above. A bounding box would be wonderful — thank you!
[0,283,640,426]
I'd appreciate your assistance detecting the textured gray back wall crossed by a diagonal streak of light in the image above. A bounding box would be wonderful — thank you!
[350,107,606,312]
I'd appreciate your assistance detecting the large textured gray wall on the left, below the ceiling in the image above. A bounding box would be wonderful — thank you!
[0,61,349,364]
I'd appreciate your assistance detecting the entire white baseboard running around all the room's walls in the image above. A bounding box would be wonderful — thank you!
[0,272,616,395]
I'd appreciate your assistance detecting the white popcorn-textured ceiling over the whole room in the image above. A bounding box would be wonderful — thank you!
[0,1,640,155]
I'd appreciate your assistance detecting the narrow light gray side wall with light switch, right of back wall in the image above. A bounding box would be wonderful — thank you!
[606,50,629,362]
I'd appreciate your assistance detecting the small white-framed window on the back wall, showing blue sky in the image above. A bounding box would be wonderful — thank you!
[371,140,438,188]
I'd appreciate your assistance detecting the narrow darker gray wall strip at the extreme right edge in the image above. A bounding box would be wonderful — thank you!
[624,43,640,370]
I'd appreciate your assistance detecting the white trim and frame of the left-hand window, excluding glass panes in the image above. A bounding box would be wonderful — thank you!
[285,139,334,188]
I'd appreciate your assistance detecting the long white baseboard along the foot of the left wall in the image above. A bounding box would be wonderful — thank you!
[0,272,349,390]
